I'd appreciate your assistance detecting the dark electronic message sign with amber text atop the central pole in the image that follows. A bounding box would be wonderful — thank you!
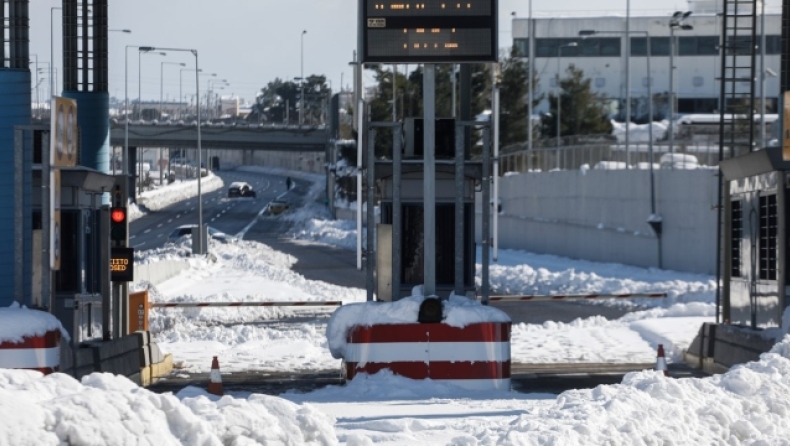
[360,0,498,63]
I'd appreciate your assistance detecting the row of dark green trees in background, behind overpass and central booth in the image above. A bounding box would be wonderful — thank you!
[248,47,612,147]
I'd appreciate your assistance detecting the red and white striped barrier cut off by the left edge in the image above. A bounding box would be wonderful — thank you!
[0,330,61,375]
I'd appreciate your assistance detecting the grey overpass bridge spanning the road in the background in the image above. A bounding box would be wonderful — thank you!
[110,121,329,152]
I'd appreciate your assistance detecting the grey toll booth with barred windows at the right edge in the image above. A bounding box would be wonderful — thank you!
[720,147,790,330]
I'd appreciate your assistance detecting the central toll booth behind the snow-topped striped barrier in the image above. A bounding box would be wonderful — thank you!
[367,118,489,301]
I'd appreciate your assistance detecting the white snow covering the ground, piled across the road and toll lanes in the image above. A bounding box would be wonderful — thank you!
[0,168,790,446]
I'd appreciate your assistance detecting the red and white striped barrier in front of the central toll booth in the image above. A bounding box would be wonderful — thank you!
[343,322,511,390]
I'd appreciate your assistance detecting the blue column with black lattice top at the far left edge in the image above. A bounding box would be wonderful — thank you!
[0,0,31,307]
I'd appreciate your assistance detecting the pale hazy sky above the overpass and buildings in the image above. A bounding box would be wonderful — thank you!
[30,0,781,105]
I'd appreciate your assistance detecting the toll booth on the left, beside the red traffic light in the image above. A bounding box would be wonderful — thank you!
[15,126,115,345]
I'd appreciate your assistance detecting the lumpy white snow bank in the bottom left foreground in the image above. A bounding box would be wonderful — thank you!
[0,370,338,446]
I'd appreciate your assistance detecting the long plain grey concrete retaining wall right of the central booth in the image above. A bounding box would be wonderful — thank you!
[476,170,718,274]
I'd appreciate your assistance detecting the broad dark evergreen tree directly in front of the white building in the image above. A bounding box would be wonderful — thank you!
[541,65,612,138]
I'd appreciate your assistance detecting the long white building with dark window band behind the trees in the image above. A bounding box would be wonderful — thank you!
[512,1,782,119]
